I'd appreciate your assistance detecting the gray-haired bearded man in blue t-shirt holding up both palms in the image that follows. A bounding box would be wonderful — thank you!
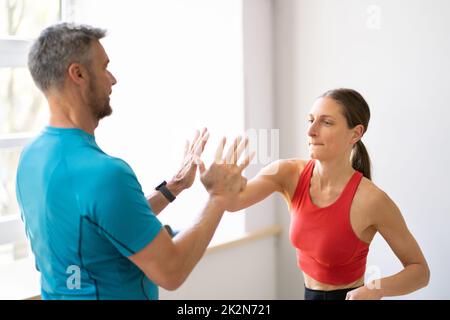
[16,23,251,299]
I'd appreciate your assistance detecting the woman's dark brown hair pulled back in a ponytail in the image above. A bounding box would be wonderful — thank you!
[321,88,371,180]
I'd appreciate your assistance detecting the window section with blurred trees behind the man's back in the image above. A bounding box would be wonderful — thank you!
[0,0,60,264]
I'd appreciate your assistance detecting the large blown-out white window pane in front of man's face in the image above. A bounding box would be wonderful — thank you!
[67,0,245,237]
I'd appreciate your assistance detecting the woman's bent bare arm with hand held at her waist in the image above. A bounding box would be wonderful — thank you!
[350,192,430,299]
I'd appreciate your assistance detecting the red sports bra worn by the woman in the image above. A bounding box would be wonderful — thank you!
[289,160,369,285]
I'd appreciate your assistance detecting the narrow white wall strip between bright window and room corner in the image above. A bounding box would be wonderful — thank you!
[242,0,279,231]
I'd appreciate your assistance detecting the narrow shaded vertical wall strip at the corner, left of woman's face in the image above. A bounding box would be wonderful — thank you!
[273,1,304,299]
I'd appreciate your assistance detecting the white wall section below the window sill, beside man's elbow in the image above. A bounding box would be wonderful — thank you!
[160,237,277,300]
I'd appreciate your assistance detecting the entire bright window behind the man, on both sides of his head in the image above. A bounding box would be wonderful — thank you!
[0,0,244,282]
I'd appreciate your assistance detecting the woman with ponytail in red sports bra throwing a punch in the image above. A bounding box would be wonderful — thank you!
[228,89,430,300]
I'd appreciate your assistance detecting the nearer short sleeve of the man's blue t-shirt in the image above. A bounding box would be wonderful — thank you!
[93,159,162,257]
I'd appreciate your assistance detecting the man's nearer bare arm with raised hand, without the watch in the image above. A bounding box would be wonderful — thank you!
[129,135,251,290]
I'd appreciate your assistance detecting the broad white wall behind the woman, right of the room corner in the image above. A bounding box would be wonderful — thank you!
[275,0,450,299]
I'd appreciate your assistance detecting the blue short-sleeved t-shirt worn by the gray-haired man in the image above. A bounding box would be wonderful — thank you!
[16,127,162,299]
